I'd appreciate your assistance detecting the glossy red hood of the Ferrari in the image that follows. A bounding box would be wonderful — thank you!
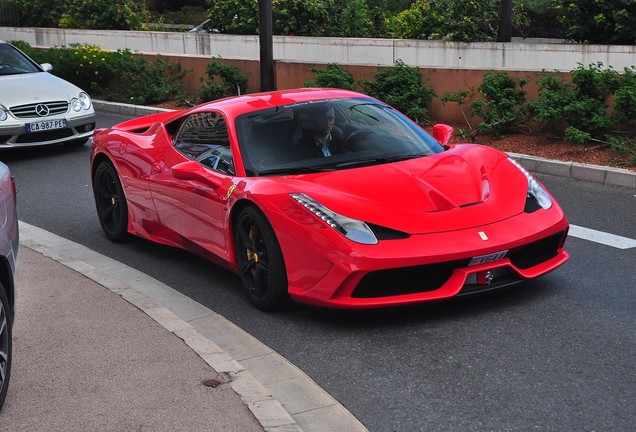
[285,144,528,234]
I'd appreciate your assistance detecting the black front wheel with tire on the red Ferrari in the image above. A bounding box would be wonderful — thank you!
[234,207,291,311]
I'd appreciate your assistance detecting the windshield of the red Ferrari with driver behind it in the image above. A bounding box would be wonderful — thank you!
[236,98,444,176]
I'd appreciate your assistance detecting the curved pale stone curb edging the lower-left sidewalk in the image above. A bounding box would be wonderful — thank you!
[19,221,367,432]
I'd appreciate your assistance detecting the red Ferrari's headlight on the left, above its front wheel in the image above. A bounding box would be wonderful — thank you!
[289,194,378,244]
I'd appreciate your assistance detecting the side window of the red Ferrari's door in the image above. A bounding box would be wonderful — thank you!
[174,112,235,175]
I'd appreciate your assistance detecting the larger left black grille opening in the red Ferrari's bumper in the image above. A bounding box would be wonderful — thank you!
[351,260,468,298]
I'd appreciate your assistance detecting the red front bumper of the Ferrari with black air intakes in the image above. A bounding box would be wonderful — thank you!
[285,207,569,309]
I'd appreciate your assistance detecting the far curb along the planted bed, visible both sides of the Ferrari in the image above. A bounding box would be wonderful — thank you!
[93,100,636,188]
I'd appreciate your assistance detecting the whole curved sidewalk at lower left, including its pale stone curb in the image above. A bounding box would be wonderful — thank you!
[0,222,366,432]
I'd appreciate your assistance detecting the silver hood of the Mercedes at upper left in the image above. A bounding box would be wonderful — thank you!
[0,72,82,108]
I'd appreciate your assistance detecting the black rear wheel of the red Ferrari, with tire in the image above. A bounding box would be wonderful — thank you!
[93,161,128,242]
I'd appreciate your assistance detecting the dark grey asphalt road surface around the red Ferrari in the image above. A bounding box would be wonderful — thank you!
[0,109,636,431]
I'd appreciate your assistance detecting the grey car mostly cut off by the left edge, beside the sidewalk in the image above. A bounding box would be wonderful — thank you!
[0,162,19,408]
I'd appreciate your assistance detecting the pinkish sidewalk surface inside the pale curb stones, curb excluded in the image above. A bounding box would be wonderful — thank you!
[0,247,263,432]
